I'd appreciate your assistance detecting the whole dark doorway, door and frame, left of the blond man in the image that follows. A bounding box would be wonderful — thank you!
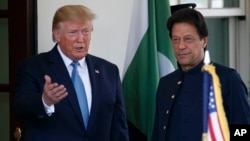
[0,0,37,141]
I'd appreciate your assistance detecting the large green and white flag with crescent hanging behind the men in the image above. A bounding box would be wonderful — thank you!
[122,0,176,140]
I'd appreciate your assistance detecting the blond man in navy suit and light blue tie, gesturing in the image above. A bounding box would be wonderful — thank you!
[14,5,128,141]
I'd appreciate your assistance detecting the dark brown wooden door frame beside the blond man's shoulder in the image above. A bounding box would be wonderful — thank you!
[7,0,37,141]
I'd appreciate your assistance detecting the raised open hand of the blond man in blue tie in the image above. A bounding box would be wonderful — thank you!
[42,75,68,106]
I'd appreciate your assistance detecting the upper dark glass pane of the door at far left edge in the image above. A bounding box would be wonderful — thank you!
[0,18,9,84]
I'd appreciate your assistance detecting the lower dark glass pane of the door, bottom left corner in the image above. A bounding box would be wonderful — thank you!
[0,92,10,141]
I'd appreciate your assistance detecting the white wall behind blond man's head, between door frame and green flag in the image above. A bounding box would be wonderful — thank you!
[37,0,133,75]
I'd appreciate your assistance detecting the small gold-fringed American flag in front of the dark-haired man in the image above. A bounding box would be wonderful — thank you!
[202,50,230,141]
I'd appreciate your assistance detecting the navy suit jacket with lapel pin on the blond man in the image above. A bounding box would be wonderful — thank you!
[14,46,128,141]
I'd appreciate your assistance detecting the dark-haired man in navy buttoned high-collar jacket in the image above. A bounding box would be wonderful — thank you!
[153,8,250,141]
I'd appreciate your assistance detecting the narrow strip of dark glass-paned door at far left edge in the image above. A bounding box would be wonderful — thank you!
[0,0,10,141]
